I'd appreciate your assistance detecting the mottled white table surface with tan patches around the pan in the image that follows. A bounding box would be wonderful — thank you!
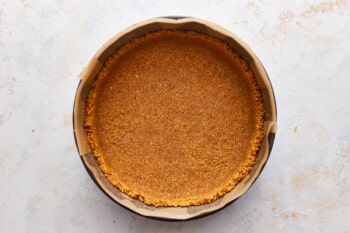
[0,0,350,233]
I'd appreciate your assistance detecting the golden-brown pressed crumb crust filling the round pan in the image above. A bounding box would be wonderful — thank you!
[85,31,264,206]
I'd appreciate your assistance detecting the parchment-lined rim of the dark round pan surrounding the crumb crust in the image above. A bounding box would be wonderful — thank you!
[73,17,277,220]
